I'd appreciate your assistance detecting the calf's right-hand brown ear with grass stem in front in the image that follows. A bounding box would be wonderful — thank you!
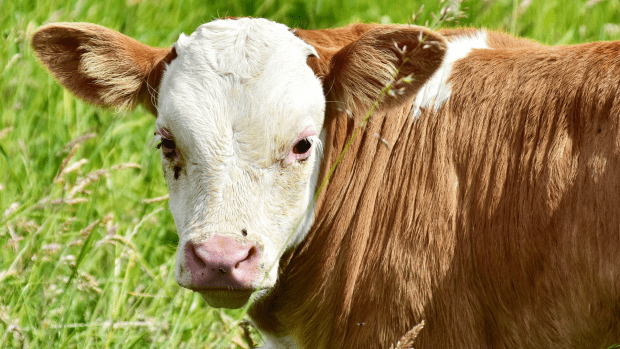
[323,26,447,114]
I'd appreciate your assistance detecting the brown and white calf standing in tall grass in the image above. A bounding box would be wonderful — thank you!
[33,18,620,349]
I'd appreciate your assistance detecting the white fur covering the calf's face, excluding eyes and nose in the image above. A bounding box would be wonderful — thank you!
[157,18,325,302]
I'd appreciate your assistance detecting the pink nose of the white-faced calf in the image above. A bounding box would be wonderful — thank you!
[185,234,259,290]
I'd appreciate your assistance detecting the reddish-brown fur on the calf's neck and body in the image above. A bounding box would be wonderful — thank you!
[251,27,620,349]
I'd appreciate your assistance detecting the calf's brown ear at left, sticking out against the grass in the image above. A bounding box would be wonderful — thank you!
[32,23,176,115]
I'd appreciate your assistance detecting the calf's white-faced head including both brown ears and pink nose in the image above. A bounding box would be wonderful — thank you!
[32,18,445,308]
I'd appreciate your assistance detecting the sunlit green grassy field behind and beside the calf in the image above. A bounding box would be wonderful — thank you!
[0,0,620,348]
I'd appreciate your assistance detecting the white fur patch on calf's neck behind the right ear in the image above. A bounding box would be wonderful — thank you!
[412,30,489,119]
